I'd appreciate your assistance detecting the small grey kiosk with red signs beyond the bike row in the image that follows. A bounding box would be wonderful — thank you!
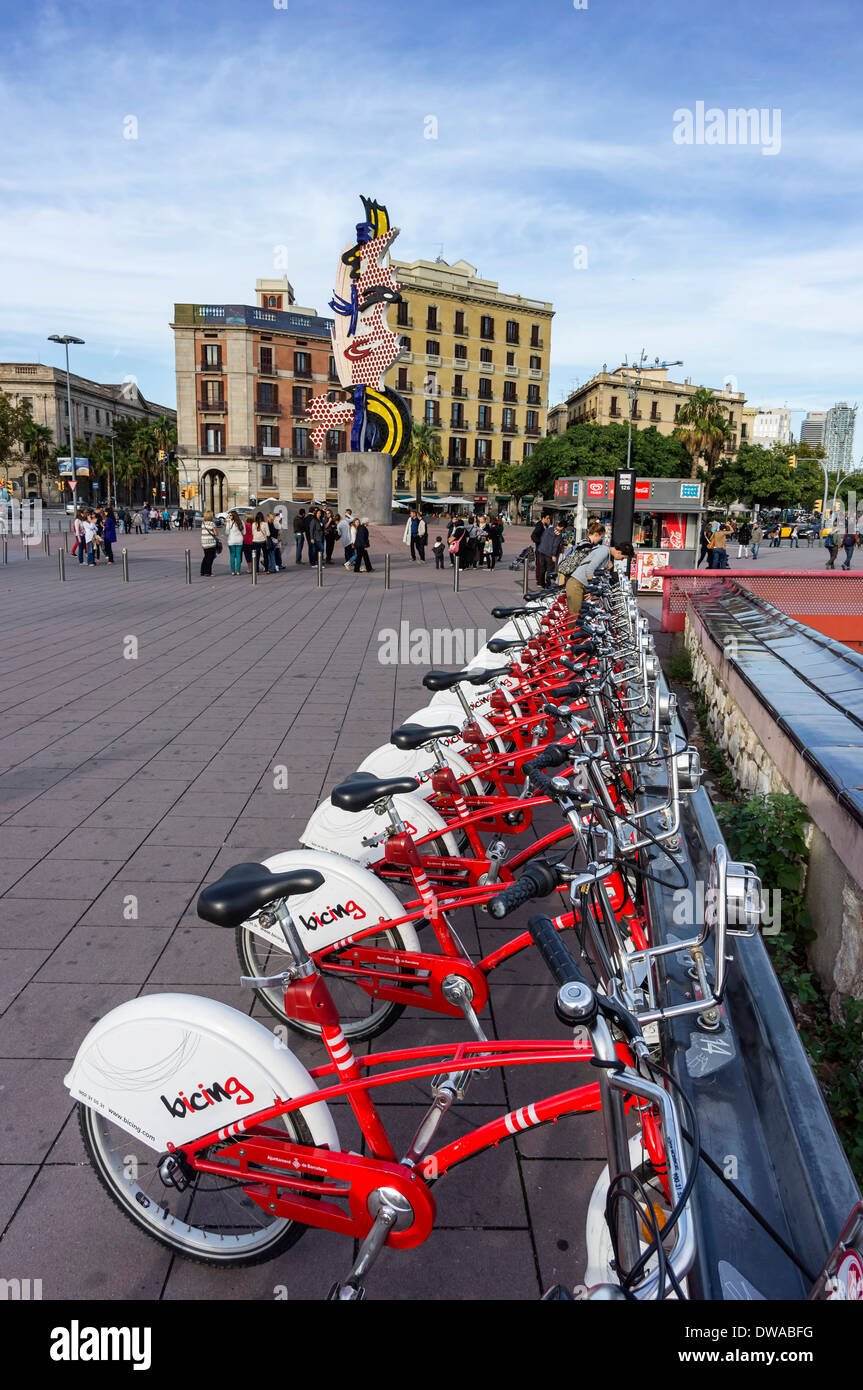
[546,478,705,614]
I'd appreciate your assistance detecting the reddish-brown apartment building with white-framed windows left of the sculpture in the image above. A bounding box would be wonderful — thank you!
[171,277,349,512]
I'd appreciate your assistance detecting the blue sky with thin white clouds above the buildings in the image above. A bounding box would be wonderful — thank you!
[0,0,863,439]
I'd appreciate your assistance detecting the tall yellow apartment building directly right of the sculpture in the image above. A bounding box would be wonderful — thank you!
[386,260,554,503]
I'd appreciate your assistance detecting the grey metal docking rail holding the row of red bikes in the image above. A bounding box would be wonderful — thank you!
[628,676,860,1300]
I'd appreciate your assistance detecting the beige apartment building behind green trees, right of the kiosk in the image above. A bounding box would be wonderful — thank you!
[567,366,745,455]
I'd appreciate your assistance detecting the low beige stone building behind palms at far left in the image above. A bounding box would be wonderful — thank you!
[0,361,176,503]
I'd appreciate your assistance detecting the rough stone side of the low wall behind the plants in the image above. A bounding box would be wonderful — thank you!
[685,613,863,998]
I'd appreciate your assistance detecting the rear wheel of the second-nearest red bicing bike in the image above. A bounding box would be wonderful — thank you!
[236,924,409,1043]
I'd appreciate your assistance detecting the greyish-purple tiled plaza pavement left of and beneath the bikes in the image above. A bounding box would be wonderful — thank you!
[0,528,602,1300]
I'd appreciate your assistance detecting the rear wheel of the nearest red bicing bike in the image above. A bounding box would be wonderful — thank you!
[78,1102,313,1266]
